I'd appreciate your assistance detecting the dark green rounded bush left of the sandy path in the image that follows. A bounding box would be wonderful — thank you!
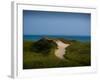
[31,38,57,54]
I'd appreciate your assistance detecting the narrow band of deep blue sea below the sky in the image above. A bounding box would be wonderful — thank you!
[23,35,91,42]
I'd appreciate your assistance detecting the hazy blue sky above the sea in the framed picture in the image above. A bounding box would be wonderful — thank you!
[23,10,91,36]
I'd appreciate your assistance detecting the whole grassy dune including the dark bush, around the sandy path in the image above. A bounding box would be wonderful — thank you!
[23,38,91,69]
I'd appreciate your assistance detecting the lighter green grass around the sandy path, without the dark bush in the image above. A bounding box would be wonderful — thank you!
[23,41,90,69]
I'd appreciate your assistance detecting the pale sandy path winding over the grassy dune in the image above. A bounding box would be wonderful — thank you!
[55,40,69,59]
